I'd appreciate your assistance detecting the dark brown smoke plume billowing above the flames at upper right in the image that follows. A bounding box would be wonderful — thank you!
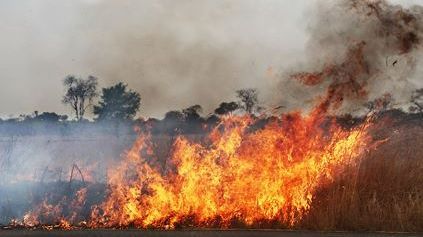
[281,0,423,115]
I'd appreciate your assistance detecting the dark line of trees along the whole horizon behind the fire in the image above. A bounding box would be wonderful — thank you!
[0,75,423,130]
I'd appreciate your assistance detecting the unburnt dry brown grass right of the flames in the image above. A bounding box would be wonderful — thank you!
[300,122,423,232]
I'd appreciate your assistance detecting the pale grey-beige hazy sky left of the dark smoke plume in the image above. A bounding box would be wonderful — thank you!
[0,0,419,117]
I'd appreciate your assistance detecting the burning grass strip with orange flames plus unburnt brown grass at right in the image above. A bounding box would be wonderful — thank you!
[1,114,423,231]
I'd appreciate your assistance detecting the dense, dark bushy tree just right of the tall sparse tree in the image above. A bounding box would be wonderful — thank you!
[94,82,141,120]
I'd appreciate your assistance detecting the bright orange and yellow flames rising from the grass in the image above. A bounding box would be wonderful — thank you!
[88,113,369,229]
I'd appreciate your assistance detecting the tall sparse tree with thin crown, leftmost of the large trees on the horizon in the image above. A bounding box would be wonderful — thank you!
[62,75,98,121]
